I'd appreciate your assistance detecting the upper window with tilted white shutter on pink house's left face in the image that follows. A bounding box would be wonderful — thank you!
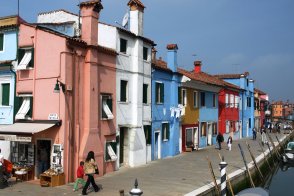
[16,48,34,70]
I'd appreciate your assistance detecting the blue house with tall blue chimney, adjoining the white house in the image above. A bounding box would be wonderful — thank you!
[150,44,181,160]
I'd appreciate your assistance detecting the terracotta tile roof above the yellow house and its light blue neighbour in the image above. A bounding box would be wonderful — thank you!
[178,68,225,87]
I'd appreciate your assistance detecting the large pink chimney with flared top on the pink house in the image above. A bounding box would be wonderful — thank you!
[80,0,103,45]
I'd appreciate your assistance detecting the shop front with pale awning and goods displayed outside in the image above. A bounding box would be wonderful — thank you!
[0,121,62,180]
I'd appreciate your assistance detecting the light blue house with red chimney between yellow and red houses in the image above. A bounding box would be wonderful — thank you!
[180,61,224,148]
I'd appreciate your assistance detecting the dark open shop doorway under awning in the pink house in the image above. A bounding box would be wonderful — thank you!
[37,140,51,178]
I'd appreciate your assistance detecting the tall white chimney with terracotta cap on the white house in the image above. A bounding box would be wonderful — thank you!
[128,0,145,36]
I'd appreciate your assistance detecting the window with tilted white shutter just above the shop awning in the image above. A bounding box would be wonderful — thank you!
[15,95,33,120]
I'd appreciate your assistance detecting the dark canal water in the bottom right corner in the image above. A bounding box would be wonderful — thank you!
[264,163,294,196]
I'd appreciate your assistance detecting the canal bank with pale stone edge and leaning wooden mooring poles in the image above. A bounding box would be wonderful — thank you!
[185,131,294,196]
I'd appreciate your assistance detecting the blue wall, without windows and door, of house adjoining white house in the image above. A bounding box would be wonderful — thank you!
[151,69,180,160]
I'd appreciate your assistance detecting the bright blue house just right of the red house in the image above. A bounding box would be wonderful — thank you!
[216,72,254,138]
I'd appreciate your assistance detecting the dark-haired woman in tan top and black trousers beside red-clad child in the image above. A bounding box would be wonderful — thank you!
[82,151,100,195]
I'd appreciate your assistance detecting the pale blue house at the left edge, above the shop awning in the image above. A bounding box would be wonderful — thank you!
[0,16,18,126]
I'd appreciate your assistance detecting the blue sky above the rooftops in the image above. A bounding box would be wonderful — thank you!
[0,0,294,102]
